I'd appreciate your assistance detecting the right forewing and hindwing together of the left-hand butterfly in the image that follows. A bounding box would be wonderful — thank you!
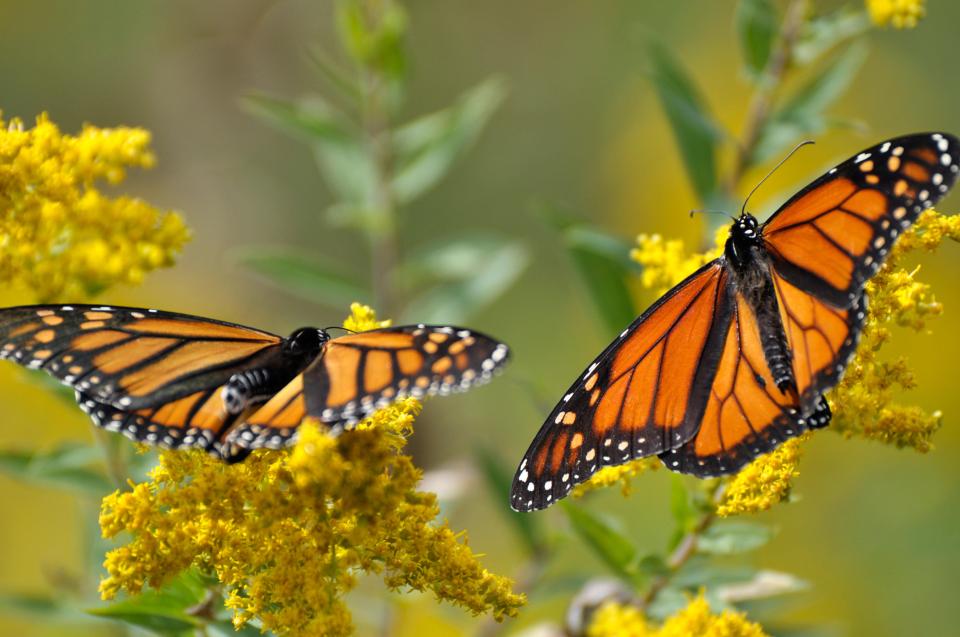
[226,325,508,450]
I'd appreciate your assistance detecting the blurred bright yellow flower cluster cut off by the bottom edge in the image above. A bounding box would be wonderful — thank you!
[587,595,766,637]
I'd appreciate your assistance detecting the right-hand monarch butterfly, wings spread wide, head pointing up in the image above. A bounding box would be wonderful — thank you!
[511,133,960,511]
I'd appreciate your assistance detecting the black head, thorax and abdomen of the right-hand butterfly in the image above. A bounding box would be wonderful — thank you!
[724,213,796,392]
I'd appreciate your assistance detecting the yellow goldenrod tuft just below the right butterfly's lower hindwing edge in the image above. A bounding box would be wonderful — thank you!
[717,434,810,517]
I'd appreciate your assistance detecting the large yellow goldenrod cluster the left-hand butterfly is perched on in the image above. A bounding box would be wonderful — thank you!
[100,305,525,635]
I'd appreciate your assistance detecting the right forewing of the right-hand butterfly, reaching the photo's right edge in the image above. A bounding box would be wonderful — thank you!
[762,133,960,307]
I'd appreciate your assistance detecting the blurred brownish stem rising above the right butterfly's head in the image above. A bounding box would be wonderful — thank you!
[724,0,809,200]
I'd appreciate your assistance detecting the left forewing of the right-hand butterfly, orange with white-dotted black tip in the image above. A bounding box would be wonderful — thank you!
[511,260,731,511]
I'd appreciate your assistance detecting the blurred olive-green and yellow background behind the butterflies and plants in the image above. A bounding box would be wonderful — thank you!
[0,0,960,636]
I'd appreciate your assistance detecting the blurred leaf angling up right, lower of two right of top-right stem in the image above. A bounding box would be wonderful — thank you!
[751,42,867,164]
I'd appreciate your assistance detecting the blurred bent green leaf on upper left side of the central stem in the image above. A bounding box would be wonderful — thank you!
[242,95,377,206]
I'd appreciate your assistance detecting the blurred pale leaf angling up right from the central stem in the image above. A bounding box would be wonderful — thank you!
[393,77,507,204]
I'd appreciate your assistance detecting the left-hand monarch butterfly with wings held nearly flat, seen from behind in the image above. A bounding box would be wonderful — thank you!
[0,305,509,462]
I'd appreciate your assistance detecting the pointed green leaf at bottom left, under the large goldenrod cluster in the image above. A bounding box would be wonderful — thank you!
[87,570,206,634]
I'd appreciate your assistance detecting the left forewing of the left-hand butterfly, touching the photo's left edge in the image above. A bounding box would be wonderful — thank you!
[0,305,281,411]
